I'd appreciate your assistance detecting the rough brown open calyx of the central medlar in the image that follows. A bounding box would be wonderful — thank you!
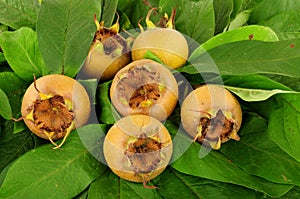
[117,65,165,109]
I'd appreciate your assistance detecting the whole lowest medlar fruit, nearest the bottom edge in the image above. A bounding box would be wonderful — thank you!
[103,115,173,188]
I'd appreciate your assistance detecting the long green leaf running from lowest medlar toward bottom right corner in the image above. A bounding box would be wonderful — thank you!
[171,143,292,197]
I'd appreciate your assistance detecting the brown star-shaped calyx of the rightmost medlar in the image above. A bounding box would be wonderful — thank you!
[194,109,240,150]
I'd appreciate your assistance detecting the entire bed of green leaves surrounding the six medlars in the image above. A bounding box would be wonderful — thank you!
[0,0,300,198]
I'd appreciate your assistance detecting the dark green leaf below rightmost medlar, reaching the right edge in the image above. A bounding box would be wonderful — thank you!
[221,116,300,186]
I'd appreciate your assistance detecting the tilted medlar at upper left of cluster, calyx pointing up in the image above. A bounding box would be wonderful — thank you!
[82,14,131,81]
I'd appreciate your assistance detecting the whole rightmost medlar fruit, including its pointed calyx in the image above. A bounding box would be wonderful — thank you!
[181,84,242,149]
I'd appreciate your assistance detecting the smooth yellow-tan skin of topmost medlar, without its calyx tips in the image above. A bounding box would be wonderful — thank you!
[131,28,189,69]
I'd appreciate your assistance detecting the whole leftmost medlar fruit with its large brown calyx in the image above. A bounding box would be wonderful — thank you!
[21,74,90,149]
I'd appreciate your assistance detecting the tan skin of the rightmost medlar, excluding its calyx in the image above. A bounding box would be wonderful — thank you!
[181,84,242,143]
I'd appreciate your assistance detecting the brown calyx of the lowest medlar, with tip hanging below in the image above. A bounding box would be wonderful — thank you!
[125,133,163,188]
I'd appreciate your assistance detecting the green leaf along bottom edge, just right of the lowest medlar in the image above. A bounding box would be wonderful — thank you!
[153,168,259,199]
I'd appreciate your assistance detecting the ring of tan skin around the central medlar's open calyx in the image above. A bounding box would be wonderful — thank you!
[110,59,178,121]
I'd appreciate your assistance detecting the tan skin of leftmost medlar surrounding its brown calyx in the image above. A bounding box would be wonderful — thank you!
[21,74,91,140]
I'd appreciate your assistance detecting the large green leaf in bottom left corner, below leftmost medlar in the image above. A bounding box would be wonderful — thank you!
[0,131,106,198]
